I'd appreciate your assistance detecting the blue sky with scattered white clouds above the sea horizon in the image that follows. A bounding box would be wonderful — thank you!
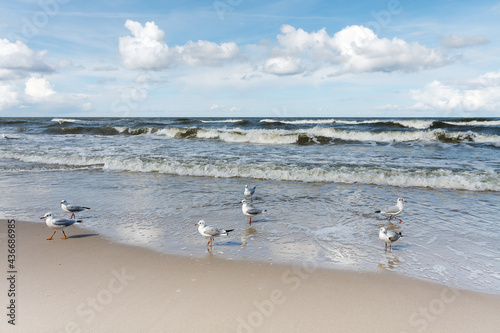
[0,0,500,117]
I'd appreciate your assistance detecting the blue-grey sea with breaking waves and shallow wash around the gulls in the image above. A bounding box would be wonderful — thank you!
[0,118,500,294]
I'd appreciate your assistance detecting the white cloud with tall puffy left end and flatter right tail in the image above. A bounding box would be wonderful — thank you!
[119,20,240,69]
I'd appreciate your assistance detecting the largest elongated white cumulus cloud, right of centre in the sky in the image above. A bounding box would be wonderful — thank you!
[264,25,450,75]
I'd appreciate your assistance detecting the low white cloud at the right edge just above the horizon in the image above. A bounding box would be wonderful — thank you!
[410,71,500,111]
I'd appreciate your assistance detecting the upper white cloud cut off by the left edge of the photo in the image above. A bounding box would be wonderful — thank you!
[0,38,53,80]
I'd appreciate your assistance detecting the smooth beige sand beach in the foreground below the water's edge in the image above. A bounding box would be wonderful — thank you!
[0,220,500,333]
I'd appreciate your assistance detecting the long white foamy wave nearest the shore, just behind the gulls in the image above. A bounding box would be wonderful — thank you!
[2,153,500,192]
